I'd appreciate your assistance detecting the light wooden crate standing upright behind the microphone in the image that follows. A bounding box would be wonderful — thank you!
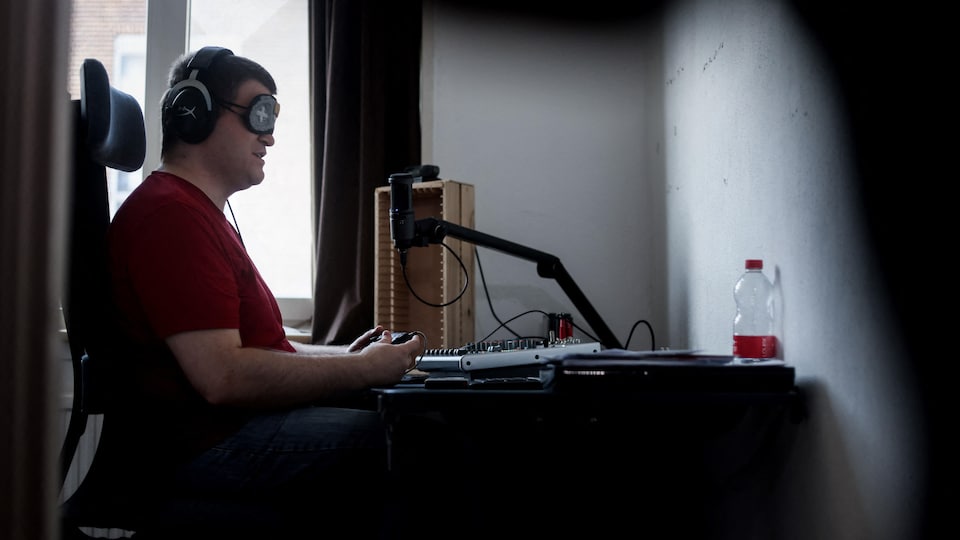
[374,180,474,349]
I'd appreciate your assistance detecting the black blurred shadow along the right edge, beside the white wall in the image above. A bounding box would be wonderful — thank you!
[794,0,956,536]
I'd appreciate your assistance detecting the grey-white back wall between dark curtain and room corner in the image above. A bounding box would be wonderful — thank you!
[424,6,667,348]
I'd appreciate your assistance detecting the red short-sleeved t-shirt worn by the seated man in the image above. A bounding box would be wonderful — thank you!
[109,171,294,464]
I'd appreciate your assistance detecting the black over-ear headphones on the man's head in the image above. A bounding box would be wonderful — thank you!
[162,47,233,144]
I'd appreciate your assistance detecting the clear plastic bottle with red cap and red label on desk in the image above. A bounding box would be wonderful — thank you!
[733,259,777,363]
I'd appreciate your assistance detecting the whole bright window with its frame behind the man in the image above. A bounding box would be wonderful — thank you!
[70,0,313,325]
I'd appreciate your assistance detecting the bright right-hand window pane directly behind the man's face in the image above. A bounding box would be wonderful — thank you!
[189,0,313,298]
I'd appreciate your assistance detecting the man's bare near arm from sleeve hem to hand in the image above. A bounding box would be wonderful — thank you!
[167,329,423,407]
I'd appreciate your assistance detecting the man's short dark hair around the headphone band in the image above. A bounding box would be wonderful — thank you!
[160,51,277,156]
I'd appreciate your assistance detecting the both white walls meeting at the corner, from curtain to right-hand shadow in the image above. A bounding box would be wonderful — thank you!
[424,0,926,540]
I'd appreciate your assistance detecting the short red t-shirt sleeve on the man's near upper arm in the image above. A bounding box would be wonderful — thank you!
[128,205,240,338]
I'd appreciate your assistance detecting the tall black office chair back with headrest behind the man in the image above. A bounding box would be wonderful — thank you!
[60,59,146,488]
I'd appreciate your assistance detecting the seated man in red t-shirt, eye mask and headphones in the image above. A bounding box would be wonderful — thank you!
[109,47,423,533]
